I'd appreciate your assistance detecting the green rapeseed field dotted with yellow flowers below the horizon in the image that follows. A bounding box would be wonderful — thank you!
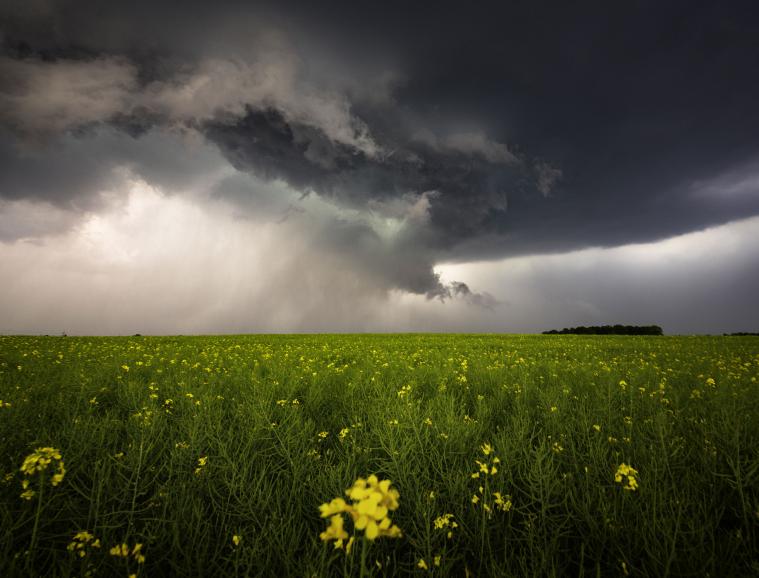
[0,335,759,578]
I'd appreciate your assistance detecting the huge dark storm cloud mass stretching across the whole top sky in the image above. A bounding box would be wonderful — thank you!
[0,0,759,297]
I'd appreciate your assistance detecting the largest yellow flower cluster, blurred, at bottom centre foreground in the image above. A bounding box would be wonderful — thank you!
[319,474,401,553]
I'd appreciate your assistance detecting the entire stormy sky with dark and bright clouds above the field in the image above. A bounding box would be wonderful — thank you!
[0,0,759,335]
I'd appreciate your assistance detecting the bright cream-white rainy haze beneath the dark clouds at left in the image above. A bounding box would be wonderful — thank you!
[0,181,476,334]
